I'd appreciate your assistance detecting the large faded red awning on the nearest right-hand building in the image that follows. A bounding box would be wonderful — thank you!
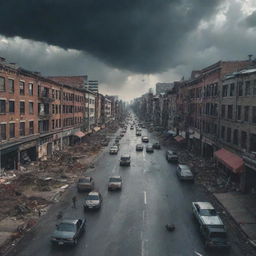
[214,148,244,173]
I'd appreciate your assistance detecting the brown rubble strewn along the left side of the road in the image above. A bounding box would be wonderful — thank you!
[0,125,118,254]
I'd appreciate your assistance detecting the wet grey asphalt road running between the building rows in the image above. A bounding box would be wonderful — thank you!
[9,124,241,256]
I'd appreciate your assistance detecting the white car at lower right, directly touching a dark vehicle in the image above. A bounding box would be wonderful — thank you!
[192,202,224,227]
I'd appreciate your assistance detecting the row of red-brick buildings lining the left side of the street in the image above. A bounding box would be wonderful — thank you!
[0,58,123,170]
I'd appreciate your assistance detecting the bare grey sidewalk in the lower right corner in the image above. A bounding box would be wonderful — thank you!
[214,192,256,243]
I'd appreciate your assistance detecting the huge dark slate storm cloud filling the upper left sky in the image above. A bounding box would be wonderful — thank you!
[0,0,221,73]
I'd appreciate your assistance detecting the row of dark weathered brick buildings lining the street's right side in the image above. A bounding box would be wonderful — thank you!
[134,60,256,191]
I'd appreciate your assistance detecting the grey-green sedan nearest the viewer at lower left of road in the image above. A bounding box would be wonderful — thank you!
[51,219,86,245]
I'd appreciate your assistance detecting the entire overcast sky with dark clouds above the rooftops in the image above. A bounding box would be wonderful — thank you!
[0,0,256,100]
